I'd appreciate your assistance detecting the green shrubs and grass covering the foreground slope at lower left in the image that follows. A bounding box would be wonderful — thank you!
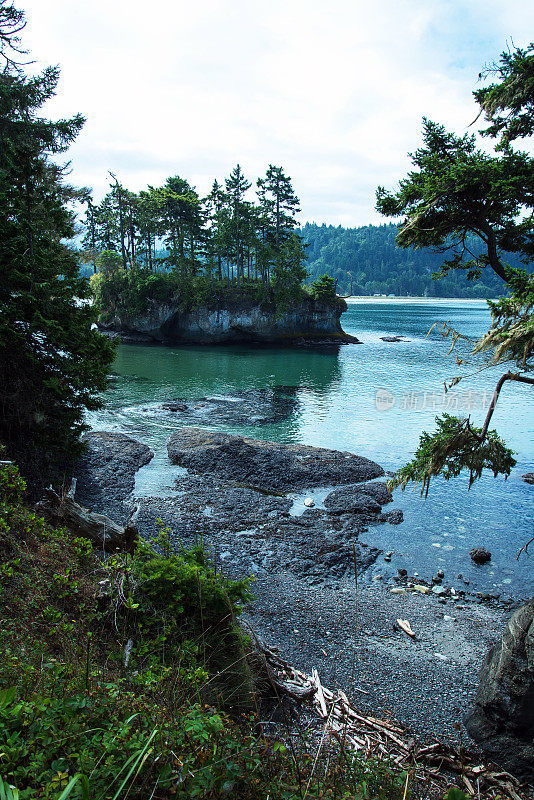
[0,466,410,800]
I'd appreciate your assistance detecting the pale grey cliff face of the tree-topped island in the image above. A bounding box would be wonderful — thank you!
[100,298,358,344]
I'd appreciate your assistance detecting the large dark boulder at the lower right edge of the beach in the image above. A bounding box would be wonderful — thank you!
[465,599,534,783]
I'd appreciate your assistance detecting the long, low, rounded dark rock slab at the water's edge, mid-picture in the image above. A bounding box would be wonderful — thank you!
[167,428,384,490]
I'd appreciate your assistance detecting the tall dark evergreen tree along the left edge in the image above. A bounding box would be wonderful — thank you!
[0,0,113,482]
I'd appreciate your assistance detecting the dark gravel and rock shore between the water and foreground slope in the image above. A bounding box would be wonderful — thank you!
[76,429,509,744]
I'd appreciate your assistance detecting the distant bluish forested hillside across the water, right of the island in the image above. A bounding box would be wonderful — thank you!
[298,223,524,298]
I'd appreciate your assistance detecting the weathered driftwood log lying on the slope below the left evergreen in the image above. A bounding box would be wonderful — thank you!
[35,478,139,553]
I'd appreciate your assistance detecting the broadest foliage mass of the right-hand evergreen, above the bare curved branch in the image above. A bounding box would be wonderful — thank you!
[376,119,534,280]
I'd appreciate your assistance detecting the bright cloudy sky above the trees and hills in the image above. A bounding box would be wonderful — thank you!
[19,0,534,227]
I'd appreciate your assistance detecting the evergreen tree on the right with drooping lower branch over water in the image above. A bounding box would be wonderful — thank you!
[377,45,534,492]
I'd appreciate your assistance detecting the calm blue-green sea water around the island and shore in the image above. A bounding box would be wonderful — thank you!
[89,300,534,598]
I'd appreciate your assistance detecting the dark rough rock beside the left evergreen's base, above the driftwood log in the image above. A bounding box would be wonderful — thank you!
[76,431,154,507]
